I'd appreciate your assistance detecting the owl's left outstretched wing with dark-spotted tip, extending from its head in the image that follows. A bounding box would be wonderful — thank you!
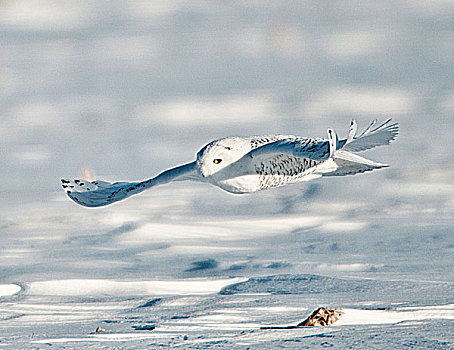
[61,162,200,207]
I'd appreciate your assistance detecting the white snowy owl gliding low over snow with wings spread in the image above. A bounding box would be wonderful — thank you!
[61,119,399,207]
